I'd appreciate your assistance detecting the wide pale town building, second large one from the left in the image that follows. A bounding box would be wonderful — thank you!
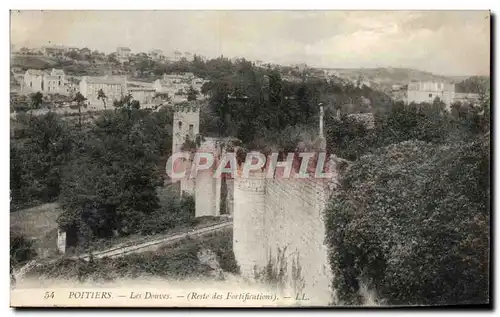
[80,76,127,108]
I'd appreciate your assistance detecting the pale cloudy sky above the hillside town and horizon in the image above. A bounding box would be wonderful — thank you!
[11,10,490,76]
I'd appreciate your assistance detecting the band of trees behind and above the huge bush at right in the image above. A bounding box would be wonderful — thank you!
[325,98,490,160]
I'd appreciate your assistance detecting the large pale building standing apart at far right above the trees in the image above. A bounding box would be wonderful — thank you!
[407,82,455,110]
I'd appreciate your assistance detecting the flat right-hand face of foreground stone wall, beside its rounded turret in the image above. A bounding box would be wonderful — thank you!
[264,179,332,305]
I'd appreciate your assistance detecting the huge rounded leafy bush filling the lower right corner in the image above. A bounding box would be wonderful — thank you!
[327,141,490,305]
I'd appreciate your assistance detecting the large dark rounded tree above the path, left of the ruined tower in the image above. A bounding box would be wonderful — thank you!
[58,111,163,241]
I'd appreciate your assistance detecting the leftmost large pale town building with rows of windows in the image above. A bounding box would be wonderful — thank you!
[22,68,69,94]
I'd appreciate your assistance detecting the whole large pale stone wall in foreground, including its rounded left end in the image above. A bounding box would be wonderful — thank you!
[233,172,332,305]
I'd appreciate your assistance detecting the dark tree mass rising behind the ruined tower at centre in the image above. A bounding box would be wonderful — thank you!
[195,59,391,147]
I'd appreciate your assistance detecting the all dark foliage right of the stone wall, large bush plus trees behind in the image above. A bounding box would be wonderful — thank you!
[326,90,490,305]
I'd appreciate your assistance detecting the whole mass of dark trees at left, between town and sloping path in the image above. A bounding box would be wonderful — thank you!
[10,108,194,243]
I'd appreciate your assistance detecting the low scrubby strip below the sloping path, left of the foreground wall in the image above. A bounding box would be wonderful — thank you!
[30,227,238,282]
